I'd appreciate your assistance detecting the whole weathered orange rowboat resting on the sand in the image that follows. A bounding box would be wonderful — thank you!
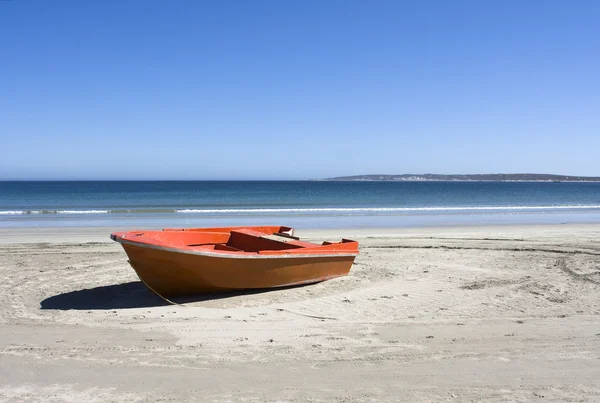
[110,227,358,297]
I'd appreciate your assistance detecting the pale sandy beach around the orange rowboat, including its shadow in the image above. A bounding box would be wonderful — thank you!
[0,225,600,402]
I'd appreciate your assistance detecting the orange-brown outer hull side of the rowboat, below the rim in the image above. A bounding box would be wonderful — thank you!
[123,243,356,298]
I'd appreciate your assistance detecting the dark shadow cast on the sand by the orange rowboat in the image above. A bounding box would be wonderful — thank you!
[40,281,301,311]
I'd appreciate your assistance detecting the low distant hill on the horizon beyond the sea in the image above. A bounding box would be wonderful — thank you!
[322,174,600,182]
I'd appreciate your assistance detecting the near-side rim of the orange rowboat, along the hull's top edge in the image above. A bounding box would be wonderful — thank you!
[111,235,359,259]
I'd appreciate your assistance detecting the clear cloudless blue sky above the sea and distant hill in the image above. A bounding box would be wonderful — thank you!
[0,0,600,179]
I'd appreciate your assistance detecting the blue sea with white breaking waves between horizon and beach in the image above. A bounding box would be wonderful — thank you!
[0,181,600,228]
